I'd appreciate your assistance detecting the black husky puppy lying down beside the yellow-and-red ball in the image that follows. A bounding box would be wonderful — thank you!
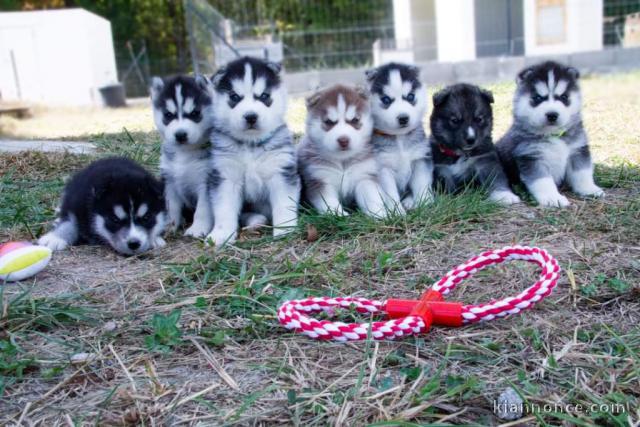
[38,157,165,255]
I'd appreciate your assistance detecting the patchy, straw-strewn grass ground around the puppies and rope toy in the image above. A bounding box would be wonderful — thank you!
[0,73,640,426]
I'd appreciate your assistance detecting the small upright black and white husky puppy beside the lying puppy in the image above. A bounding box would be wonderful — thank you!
[151,76,213,237]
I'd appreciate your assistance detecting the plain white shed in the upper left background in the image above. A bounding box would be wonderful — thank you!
[0,9,117,106]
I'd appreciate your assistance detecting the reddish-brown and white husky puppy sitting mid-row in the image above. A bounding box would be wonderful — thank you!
[298,85,386,217]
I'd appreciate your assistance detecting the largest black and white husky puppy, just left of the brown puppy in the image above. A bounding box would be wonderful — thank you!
[208,57,300,246]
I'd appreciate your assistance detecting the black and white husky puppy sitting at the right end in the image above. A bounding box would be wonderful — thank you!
[498,61,604,207]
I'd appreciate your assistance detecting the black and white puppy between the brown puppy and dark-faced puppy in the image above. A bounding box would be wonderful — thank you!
[366,63,433,213]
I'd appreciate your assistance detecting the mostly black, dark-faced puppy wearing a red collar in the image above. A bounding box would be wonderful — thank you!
[430,84,520,205]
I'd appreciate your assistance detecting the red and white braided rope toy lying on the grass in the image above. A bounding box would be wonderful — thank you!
[278,246,560,341]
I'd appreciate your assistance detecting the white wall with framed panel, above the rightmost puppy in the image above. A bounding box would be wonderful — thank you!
[524,0,603,55]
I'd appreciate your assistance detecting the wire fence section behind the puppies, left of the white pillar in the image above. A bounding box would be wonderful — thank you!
[184,0,394,72]
